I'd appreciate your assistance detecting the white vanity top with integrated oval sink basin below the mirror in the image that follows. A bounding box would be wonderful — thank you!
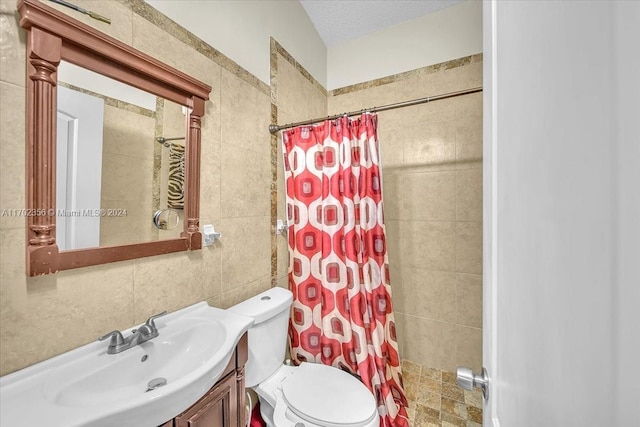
[0,302,253,427]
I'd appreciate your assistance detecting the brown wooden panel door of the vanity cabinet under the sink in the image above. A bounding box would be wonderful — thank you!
[175,371,237,427]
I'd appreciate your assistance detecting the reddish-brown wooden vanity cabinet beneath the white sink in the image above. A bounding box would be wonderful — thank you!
[160,333,248,427]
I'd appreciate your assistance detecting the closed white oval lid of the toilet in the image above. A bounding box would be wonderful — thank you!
[282,363,378,425]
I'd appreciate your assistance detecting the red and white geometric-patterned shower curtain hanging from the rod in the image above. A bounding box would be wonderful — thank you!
[282,113,409,427]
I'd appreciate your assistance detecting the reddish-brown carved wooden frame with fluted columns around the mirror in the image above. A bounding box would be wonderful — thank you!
[18,0,211,276]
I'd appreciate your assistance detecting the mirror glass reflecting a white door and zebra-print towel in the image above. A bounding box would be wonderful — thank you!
[56,61,188,250]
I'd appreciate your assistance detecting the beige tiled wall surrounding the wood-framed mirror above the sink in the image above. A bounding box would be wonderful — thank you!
[0,0,271,375]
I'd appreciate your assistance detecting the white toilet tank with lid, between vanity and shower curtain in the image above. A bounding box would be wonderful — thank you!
[229,287,293,387]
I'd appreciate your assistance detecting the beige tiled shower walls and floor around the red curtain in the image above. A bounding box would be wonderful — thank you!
[271,39,482,426]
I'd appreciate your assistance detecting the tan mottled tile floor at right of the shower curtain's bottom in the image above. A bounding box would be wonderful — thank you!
[402,360,482,427]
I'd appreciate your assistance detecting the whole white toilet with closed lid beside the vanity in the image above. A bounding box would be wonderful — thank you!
[229,288,380,427]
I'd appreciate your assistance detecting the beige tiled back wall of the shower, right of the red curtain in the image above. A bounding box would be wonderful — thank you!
[328,55,482,371]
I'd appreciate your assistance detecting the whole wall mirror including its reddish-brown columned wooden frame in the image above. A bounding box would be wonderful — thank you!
[18,0,211,276]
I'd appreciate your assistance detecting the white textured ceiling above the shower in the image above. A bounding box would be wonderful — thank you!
[300,0,464,47]
